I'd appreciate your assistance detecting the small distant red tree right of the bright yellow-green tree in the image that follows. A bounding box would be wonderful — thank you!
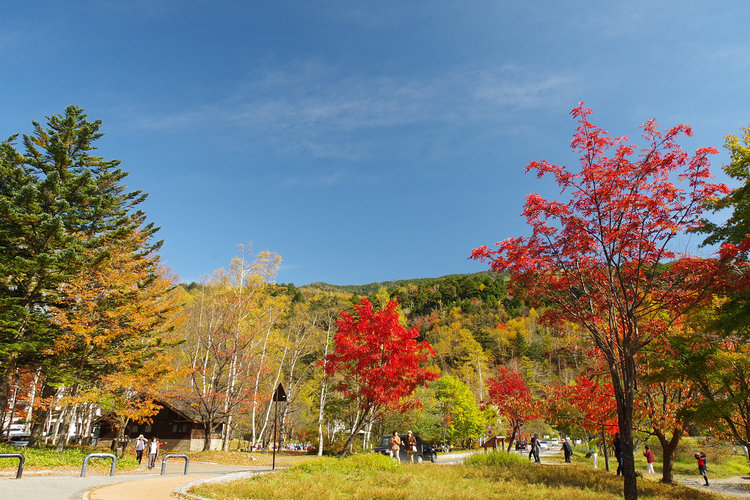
[485,366,542,451]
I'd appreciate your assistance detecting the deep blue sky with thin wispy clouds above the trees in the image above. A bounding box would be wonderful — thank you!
[0,0,750,285]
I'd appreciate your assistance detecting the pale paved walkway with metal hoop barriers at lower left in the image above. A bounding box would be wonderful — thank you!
[0,461,270,500]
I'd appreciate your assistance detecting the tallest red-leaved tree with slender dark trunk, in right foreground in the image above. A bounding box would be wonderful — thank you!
[472,103,728,499]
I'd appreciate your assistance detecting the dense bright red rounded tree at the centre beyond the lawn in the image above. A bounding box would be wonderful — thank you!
[324,298,437,455]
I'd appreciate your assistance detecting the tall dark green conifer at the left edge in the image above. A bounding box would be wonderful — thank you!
[0,106,160,434]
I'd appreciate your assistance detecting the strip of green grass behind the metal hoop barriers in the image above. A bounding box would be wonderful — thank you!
[0,444,138,471]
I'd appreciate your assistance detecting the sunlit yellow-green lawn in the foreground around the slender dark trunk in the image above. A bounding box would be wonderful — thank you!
[192,452,722,500]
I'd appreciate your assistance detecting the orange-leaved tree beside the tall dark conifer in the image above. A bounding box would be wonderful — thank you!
[49,231,182,454]
